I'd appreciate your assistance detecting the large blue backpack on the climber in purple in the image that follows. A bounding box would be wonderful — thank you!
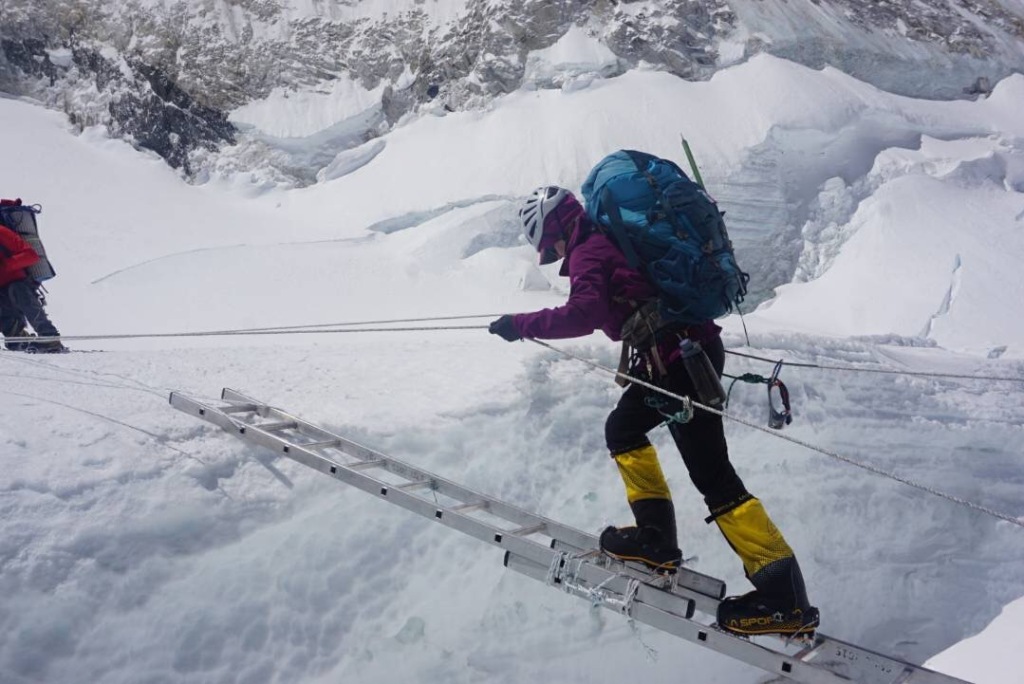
[583,149,750,325]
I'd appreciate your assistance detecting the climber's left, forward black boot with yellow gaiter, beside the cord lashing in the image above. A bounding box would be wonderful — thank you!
[600,444,682,573]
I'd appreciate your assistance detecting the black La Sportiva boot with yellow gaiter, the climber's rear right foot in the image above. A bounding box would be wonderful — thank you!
[713,495,819,637]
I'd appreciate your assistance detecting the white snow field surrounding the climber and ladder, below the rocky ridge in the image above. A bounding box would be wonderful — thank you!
[0,48,1024,684]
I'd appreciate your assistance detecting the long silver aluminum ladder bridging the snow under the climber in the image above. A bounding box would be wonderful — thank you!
[170,388,968,684]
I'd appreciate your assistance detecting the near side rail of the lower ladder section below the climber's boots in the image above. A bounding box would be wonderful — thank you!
[506,554,850,684]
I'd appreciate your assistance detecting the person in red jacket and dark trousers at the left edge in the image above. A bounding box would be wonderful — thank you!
[0,224,67,353]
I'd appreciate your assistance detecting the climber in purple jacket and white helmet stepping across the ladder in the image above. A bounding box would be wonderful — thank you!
[489,186,819,636]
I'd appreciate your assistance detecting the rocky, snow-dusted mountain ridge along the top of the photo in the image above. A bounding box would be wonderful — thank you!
[0,0,1024,183]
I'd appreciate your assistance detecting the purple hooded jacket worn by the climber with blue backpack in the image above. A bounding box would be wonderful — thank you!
[513,215,721,350]
